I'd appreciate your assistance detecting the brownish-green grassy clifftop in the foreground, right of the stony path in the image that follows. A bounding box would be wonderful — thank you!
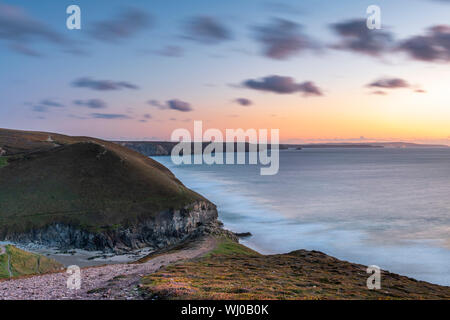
[142,240,450,299]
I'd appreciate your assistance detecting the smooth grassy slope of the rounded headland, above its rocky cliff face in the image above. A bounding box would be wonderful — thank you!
[0,129,204,236]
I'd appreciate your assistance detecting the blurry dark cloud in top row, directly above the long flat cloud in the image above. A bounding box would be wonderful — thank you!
[254,19,317,60]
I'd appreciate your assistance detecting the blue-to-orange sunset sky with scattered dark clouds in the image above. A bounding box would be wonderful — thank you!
[0,0,450,145]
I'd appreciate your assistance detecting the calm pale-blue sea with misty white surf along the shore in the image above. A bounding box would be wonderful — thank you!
[154,149,450,285]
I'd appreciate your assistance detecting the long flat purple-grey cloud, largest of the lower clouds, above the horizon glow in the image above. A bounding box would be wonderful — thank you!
[243,75,323,96]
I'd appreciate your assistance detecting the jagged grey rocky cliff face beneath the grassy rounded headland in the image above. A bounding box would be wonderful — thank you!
[5,201,220,253]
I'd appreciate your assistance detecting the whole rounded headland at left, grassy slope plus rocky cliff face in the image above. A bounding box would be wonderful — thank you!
[0,129,219,252]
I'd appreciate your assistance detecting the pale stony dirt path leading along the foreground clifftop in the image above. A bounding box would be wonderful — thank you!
[0,237,216,300]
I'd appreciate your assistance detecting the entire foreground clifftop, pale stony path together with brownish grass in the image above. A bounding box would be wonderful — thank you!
[0,232,450,300]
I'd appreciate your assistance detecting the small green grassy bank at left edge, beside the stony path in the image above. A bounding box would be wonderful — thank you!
[0,245,63,279]
